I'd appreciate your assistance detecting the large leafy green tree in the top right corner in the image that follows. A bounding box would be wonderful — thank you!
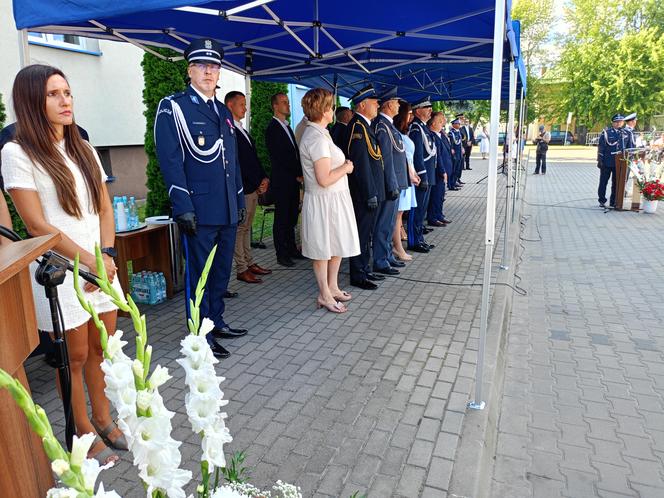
[558,0,664,128]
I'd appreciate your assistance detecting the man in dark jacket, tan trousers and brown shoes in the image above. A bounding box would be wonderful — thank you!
[224,91,272,284]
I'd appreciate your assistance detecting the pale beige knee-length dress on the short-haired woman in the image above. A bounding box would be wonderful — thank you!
[300,122,360,260]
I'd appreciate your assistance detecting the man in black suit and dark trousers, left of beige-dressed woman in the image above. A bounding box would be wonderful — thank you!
[265,93,304,267]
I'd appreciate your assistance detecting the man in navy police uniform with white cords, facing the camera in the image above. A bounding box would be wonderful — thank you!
[154,38,247,358]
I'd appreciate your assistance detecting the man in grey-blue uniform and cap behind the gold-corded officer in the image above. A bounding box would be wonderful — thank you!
[373,88,408,275]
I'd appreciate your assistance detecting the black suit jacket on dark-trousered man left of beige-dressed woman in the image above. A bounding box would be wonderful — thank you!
[265,117,302,194]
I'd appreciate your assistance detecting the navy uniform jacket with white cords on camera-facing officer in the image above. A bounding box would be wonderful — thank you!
[154,86,244,225]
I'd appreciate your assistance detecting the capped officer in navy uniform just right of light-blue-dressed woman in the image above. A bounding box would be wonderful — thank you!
[408,97,436,253]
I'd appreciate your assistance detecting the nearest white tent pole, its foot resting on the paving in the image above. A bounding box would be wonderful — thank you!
[468,0,505,410]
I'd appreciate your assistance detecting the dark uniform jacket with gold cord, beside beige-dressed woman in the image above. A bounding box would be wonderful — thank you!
[343,114,385,204]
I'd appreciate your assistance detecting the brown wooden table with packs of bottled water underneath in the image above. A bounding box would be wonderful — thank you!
[115,225,173,318]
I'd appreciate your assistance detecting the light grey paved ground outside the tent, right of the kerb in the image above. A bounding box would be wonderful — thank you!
[490,154,664,498]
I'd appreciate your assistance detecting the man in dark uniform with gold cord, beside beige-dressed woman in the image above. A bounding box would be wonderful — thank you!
[344,86,385,290]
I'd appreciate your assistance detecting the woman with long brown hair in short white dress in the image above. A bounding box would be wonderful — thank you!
[2,64,127,463]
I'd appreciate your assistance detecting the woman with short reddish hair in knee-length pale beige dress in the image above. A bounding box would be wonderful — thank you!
[300,88,360,313]
